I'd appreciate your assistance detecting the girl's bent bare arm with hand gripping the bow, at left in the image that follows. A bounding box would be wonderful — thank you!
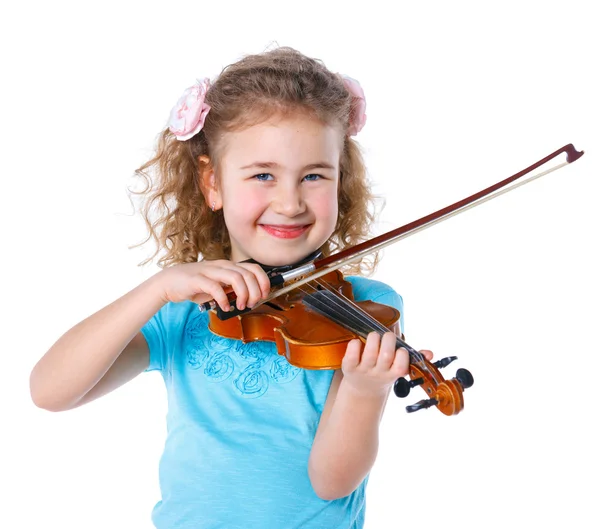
[30,260,270,411]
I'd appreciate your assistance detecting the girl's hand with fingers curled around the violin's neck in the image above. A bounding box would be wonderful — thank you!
[342,332,433,396]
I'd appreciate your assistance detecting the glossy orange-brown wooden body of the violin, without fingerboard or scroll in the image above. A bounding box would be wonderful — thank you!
[208,270,400,369]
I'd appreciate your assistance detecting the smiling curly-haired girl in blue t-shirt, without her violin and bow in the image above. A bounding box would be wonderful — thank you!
[31,48,432,529]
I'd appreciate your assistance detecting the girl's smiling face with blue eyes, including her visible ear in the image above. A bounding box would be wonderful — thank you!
[204,114,343,266]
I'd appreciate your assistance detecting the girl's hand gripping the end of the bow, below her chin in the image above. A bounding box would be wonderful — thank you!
[157,259,271,312]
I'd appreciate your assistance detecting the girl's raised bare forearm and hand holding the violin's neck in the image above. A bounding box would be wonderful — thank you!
[308,333,433,500]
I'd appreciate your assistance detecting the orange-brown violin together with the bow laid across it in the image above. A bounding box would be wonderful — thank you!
[199,144,583,415]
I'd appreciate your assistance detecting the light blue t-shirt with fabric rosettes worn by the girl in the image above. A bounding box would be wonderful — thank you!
[142,277,403,529]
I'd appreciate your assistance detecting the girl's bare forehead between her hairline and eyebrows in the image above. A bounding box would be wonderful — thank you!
[221,114,344,168]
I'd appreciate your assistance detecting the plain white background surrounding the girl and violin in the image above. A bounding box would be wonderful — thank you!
[0,0,600,529]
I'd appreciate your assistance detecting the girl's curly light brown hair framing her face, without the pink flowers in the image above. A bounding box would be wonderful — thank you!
[131,47,378,274]
